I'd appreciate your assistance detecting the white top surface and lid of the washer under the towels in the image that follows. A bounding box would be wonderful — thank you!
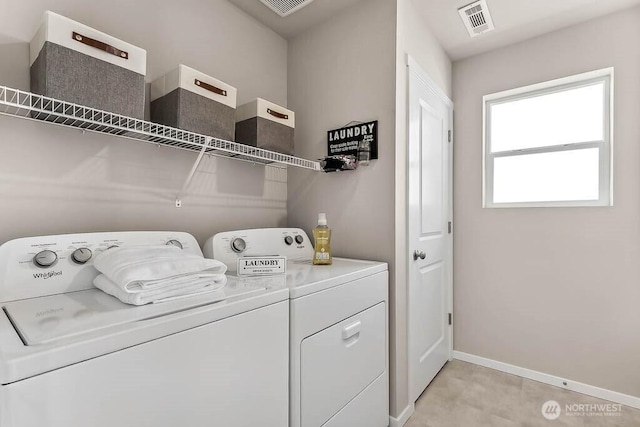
[0,277,289,384]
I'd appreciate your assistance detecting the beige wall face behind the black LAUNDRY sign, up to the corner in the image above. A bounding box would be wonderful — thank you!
[288,0,396,414]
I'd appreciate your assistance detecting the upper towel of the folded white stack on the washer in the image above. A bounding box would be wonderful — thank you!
[93,246,227,288]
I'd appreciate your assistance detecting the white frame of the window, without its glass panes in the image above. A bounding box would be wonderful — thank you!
[482,68,614,208]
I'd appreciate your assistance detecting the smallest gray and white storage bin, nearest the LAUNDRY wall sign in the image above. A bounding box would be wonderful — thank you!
[236,98,295,155]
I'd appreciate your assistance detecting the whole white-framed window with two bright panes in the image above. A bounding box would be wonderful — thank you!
[483,68,613,207]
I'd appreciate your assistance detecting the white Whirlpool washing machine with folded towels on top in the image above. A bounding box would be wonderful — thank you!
[0,232,289,427]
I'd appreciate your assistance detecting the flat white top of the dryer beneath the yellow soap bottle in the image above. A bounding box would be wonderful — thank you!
[287,257,388,299]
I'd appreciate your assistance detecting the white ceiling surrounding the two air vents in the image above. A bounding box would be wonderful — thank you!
[229,0,640,61]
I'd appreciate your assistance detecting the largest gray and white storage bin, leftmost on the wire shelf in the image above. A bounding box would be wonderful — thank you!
[30,11,147,119]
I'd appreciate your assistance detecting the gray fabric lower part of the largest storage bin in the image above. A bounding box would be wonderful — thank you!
[31,41,145,120]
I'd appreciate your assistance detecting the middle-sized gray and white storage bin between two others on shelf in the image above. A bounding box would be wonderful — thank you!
[151,65,237,141]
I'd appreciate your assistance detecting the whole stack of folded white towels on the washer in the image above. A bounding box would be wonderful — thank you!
[93,246,227,305]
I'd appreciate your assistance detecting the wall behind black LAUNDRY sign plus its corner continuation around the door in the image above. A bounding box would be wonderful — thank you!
[288,0,451,417]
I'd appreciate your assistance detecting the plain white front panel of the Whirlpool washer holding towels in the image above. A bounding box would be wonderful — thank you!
[0,301,289,427]
